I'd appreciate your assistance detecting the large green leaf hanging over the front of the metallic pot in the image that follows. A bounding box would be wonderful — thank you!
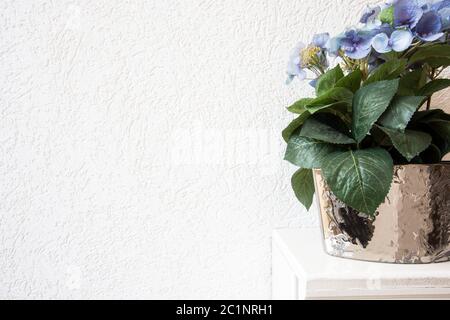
[322,148,393,216]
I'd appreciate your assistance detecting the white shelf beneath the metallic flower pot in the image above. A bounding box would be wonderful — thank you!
[272,229,450,299]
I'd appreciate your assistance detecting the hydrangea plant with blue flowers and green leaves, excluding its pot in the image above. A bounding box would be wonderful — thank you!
[283,0,450,216]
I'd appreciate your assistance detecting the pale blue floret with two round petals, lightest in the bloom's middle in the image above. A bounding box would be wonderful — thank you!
[372,30,414,53]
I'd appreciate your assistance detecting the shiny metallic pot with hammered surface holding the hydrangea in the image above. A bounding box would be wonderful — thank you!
[314,162,450,263]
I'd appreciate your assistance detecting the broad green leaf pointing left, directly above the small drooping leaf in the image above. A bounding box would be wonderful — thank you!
[284,132,340,169]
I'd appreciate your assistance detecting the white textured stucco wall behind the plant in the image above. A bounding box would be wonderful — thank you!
[0,0,448,299]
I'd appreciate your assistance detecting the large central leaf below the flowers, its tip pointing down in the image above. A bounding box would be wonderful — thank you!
[352,79,399,143]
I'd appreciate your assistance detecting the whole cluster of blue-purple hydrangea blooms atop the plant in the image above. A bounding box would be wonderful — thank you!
[288,0,450,84]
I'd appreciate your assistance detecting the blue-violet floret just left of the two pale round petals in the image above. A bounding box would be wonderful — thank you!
[340,29,373,59]
